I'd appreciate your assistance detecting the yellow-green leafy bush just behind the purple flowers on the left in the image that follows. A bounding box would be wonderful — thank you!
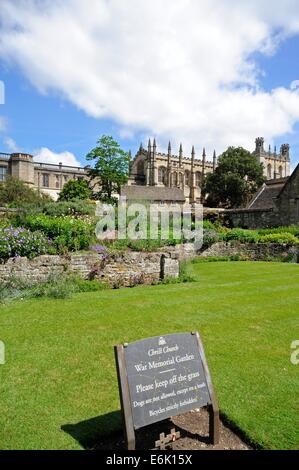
[24,214,94,253]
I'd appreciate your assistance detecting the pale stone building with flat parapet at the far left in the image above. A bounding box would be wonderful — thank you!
[0,153,87,200]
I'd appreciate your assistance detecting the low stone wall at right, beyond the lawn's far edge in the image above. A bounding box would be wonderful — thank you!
[200,242,299,262]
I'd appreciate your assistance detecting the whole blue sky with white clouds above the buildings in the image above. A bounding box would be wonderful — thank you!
[0,0,299,168]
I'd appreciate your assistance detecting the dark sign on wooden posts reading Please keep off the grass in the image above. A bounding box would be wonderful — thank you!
[115,332,219,450]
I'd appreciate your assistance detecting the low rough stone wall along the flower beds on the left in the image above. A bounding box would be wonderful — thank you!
[0,252,179,287]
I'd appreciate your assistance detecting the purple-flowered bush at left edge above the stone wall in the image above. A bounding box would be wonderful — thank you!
[0,227,51,260]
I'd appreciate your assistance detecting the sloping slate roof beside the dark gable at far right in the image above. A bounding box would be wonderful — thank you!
[247,178,288,209]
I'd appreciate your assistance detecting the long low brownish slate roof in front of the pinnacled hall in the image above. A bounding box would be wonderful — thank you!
[121,186,185,202]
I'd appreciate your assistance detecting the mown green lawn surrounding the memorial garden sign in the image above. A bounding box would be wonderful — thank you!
[0,262,299,449]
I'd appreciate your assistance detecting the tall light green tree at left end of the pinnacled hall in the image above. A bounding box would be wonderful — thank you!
[86,135,130,200]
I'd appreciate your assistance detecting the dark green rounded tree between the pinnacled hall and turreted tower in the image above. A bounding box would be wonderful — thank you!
[203,147,265,208]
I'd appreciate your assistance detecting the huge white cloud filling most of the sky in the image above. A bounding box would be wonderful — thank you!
[0,0,299,156]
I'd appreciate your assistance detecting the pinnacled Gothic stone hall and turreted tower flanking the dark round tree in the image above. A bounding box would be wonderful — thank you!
[128,137,290,203]
